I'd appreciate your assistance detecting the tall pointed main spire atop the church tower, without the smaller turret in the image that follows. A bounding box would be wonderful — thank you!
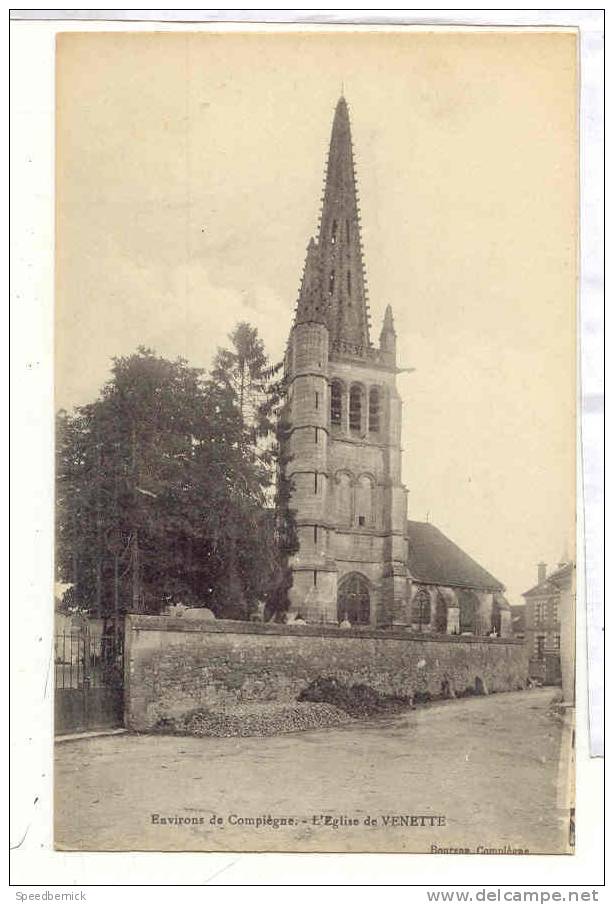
[318,97,370,351]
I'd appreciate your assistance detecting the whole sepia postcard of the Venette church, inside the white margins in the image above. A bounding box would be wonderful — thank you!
[54,27,578,856]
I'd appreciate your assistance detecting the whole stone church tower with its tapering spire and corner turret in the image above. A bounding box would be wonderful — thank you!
[286,97,409,624]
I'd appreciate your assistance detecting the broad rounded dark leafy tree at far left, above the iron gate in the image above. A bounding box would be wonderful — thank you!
[58,349,212,612]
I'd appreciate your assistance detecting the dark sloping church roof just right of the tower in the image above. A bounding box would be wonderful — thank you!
[407,521,503,591]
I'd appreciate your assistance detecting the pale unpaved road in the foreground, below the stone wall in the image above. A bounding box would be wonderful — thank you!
[55,689,568,853]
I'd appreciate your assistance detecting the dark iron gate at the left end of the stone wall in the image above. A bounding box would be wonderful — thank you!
[55,627,124,735]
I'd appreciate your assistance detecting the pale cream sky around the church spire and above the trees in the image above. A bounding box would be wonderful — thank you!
[56,30,577,603]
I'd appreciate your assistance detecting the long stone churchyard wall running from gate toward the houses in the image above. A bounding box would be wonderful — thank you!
[125,616,528,730]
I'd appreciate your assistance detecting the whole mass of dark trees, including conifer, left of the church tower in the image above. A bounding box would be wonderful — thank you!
[57,324,297,619]
